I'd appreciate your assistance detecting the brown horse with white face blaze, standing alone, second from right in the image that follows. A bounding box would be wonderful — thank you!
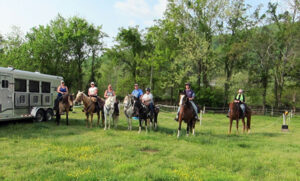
[177,92,196,138]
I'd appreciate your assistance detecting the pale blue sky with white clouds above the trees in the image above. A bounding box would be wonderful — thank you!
[0,0,288,46]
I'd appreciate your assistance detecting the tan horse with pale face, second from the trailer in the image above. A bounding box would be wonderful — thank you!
[75,91,104,128]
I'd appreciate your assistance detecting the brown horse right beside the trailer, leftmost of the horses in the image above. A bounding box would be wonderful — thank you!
[56,94,73,125]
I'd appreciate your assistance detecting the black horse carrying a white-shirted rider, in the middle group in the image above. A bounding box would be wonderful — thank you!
[133,97,159,133]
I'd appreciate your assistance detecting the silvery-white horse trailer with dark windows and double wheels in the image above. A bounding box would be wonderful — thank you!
[0,67,63,121]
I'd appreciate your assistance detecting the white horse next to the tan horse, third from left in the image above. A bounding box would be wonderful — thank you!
[104,96,117,130]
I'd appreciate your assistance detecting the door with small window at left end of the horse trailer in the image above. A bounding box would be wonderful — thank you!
[0,73,13,117]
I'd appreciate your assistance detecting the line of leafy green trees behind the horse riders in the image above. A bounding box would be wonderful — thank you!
[0,0,300,109]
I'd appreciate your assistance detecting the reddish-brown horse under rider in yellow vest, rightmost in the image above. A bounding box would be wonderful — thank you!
[228,102,251,134]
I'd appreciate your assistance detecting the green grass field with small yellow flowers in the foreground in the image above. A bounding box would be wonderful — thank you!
[0,110,300,181]
